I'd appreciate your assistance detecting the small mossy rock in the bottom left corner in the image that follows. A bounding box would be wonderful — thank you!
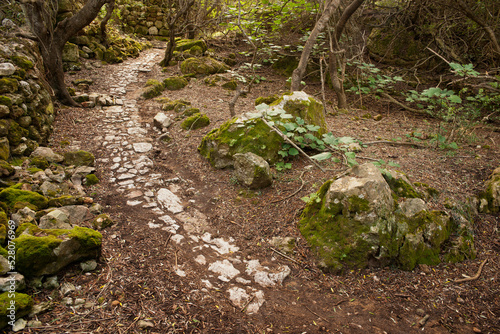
[0,292,34,329]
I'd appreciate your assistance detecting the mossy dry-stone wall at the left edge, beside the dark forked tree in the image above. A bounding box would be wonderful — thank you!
[0,32,54,160]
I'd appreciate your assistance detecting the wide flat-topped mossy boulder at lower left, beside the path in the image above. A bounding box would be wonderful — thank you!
[14,224,102,277]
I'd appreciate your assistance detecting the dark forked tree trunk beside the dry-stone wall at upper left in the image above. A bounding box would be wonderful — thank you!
[21,0,114,106]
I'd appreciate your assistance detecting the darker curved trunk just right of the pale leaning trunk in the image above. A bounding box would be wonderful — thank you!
[328,0,364,109]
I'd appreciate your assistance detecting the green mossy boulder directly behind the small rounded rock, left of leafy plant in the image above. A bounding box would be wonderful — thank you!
[198,118,283,168]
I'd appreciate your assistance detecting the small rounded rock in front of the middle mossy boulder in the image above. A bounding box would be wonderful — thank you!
[233,152,272,189]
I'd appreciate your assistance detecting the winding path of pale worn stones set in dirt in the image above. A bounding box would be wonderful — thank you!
[87,50,290,313]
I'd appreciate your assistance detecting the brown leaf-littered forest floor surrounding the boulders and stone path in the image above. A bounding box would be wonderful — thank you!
[25,39,500,333]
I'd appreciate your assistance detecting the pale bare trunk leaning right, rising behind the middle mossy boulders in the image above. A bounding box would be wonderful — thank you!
[291,0,340,92]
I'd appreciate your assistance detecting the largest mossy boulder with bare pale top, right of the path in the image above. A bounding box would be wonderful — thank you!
[299,164,475,272]
